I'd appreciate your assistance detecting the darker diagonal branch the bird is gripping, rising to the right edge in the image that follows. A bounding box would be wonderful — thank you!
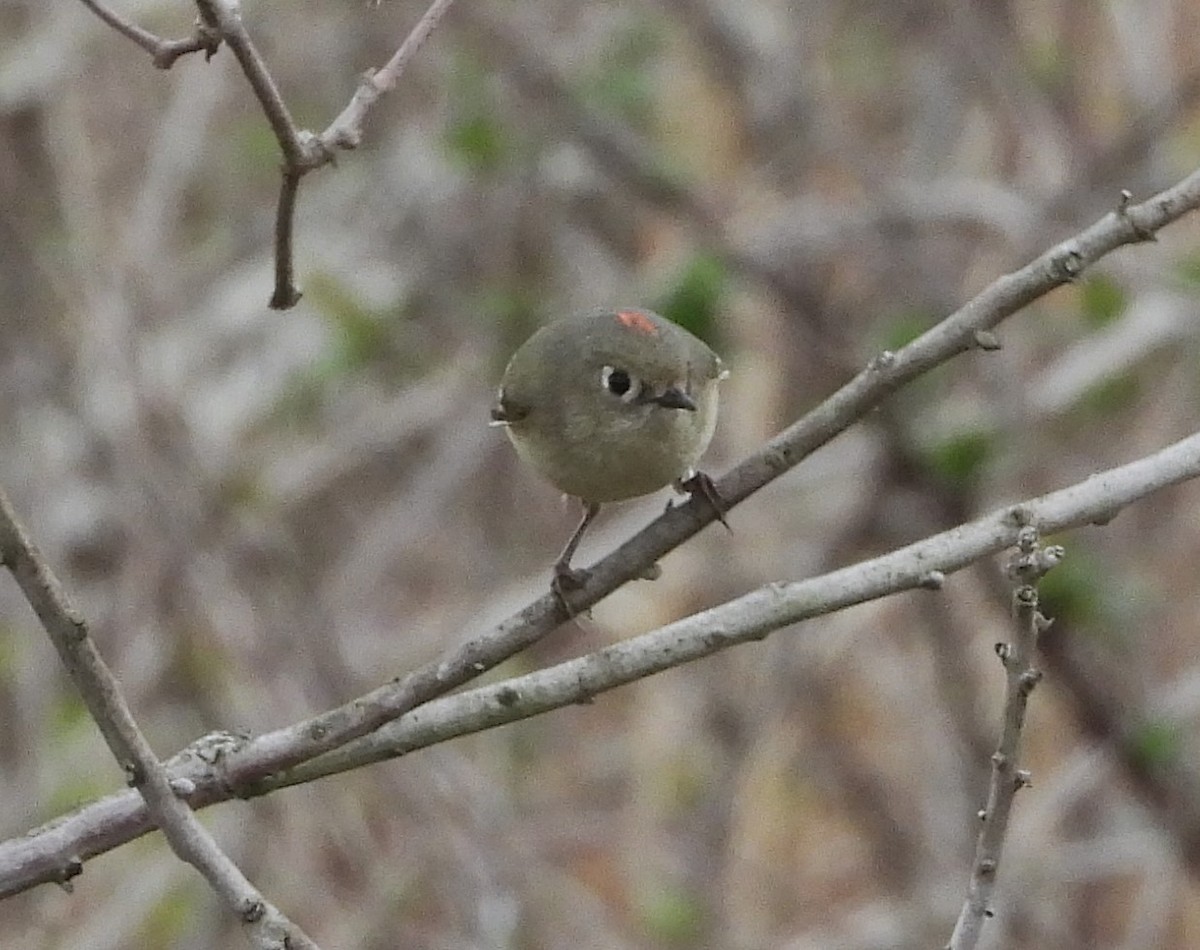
[192,163,1200,787]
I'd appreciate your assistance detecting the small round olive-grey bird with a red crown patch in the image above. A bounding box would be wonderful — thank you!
[491,308,728,601]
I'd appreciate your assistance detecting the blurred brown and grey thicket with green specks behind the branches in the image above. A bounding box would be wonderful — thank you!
[0,0,1200,950]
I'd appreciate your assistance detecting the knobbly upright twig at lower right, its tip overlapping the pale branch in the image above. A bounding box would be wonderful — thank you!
[947,527,1060,950]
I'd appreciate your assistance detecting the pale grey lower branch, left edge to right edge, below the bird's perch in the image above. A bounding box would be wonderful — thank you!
[0,435,1200,897]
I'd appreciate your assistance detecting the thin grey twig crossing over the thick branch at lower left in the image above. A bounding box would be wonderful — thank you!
[0,488,317,950]
